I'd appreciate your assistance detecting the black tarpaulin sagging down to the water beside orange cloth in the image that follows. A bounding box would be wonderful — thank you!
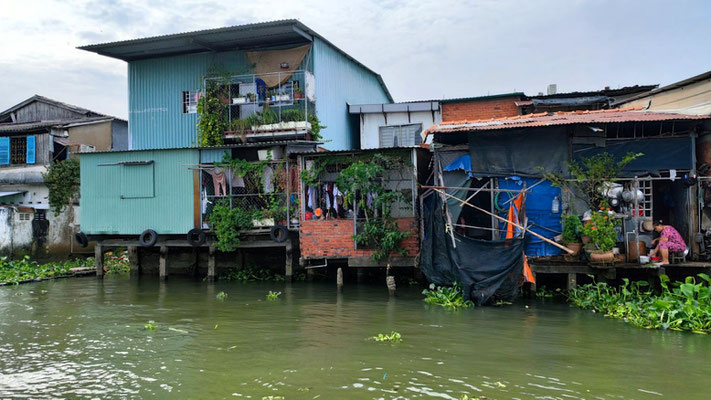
[419,193,524,305]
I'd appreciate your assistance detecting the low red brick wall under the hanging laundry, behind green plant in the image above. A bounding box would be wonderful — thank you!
[299,218,419,259]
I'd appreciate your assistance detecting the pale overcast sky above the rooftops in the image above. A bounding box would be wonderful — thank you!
[0,0,711,118]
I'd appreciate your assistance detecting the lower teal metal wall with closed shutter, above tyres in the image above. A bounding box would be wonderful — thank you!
[80,149,199,235]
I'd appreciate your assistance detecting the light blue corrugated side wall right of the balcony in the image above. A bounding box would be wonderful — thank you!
[313,38,390,150]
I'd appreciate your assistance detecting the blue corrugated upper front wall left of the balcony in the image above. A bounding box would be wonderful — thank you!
[128,51,251,150]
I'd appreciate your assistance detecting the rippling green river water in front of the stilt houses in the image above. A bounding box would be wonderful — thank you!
[0,277,711,399]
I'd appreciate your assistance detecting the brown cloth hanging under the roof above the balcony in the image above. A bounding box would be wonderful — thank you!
[247,44,311,87]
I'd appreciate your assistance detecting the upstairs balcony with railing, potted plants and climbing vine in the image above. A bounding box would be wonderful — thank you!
[204,70,318,143]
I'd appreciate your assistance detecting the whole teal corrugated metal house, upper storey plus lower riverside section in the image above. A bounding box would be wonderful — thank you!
[81,20,392,236]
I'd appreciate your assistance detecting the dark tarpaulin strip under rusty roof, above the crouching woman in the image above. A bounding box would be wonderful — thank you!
[573,137,693,176]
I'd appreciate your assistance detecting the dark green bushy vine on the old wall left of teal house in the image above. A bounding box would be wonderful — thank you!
[42,158,80,215]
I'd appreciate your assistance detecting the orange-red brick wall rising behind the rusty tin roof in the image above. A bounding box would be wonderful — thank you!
[442,96,519,122]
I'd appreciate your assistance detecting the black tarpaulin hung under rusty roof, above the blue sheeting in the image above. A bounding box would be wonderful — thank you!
[468,127,568,176]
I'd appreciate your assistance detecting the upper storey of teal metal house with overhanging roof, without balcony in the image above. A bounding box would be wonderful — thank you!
[80,20,392,150]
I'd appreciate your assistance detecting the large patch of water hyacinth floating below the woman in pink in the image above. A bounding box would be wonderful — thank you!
[569,274,711,333]
